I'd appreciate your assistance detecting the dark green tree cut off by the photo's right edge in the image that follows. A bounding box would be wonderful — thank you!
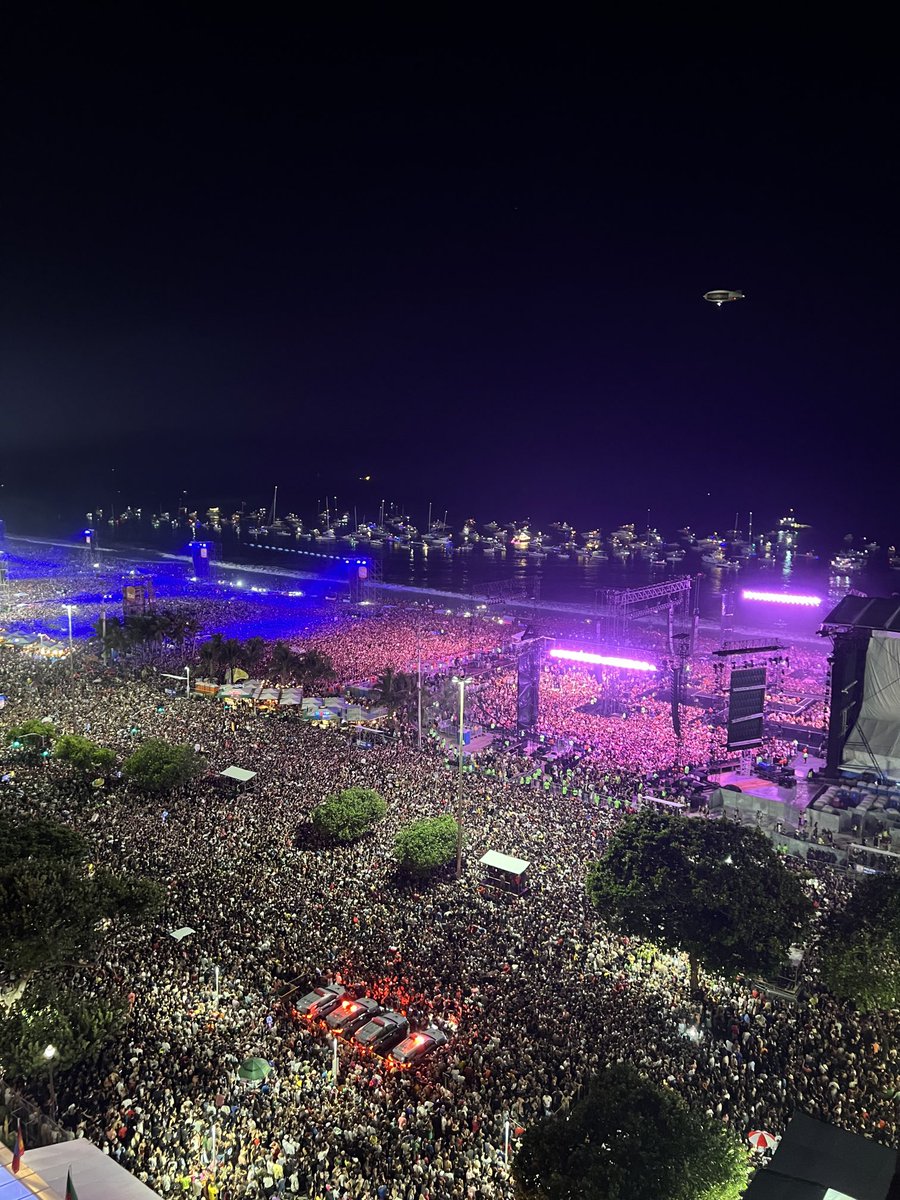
[820,875,900,1014]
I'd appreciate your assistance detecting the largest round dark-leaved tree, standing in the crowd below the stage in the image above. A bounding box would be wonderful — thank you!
[587,811,812,991]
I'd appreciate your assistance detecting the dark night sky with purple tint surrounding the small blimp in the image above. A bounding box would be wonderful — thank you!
[0,4,900,548]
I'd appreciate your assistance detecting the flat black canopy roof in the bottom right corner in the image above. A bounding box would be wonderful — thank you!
[744,1112,898,1200]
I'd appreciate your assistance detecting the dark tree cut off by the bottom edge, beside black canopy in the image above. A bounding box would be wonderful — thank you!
[512,1063,749,1200]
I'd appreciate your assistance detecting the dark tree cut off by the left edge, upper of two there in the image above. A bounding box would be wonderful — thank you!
[0,816,166,1004]
